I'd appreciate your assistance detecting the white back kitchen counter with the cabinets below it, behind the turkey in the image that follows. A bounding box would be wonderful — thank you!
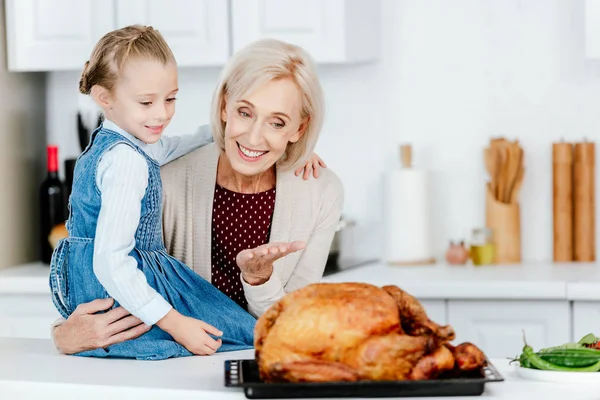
[5,263,600,382]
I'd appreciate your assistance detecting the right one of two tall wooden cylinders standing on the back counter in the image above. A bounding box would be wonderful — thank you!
[573,141,596,262]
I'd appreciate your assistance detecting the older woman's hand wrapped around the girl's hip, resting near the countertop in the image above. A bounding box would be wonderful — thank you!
[54,298,151,354]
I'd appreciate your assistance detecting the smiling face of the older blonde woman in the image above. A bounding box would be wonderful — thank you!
[221,79,308,176]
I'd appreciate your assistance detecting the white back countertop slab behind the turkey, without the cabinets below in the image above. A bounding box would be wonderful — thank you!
[5,263,600,301]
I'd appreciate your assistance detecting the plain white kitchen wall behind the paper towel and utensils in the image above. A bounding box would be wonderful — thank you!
[47,0,600,260]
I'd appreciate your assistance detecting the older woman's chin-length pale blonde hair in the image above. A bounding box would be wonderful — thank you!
[211,39,325,169]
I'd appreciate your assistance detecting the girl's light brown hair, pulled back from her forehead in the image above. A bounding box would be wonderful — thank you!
[79,25,175,94]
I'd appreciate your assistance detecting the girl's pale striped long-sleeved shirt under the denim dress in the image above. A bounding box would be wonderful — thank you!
[94,120,213,325]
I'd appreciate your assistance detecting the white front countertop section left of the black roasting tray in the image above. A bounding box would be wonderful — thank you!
[0,338,254,400]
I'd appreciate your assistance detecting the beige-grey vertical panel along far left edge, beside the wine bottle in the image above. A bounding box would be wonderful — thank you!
[0,0,46,268]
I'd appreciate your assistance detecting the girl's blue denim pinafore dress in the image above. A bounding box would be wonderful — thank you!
[50,126,256,360]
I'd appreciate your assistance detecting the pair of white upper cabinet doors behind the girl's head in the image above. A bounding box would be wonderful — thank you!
[6,0,230,71]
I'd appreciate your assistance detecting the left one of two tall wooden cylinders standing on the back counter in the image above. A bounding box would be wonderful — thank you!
[552,142,573,262]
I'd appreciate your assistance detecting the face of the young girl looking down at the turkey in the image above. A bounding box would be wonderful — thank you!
[101,60,179,144]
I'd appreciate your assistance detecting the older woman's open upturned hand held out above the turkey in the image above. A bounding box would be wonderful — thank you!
[235,241,306,286]
